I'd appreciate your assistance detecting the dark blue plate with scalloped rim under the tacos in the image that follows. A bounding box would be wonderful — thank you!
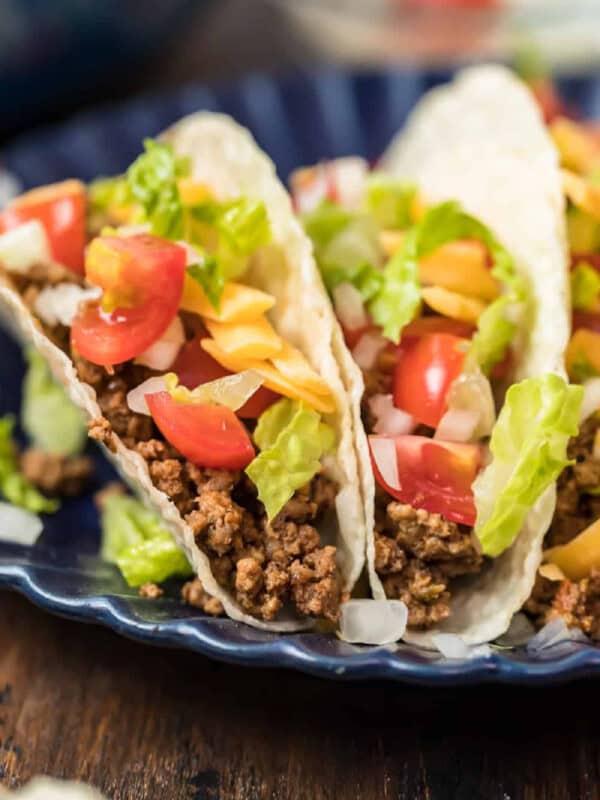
[0,71,600,685]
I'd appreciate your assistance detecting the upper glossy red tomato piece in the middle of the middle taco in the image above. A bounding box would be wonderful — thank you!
[394,333,467,428]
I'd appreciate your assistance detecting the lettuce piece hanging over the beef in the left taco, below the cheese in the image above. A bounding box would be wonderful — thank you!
[246,398,335,519]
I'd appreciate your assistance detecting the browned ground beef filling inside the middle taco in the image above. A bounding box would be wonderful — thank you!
[362,358,483,630]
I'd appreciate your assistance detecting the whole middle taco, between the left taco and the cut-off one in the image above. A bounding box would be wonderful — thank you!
[291,67,581,644]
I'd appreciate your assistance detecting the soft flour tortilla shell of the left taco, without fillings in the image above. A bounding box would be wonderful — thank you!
[0,113,366,631]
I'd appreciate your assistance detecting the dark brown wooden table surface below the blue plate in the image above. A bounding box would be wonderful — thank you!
[0,592,600,800]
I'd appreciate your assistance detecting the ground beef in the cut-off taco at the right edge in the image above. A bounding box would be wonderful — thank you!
[524,416,600,639]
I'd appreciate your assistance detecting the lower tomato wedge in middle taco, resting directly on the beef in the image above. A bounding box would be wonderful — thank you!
[369,435,482,525]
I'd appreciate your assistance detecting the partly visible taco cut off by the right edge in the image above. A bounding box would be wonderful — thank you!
[525,94,600,639]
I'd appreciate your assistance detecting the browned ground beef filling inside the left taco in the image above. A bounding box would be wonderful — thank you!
[74,355,342,621]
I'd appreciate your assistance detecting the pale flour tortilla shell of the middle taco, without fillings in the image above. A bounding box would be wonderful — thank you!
[353,66,569,645]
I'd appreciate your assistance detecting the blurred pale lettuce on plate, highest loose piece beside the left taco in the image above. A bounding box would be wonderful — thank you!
[21,348,87,456]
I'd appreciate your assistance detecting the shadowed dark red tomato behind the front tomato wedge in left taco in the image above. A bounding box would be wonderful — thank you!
[170,334,281,419]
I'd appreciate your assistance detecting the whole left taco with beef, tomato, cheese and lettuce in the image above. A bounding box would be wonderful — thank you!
[0,113,365,630]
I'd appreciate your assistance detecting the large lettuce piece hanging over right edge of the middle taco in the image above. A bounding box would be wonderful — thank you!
[473,374,583,557]
